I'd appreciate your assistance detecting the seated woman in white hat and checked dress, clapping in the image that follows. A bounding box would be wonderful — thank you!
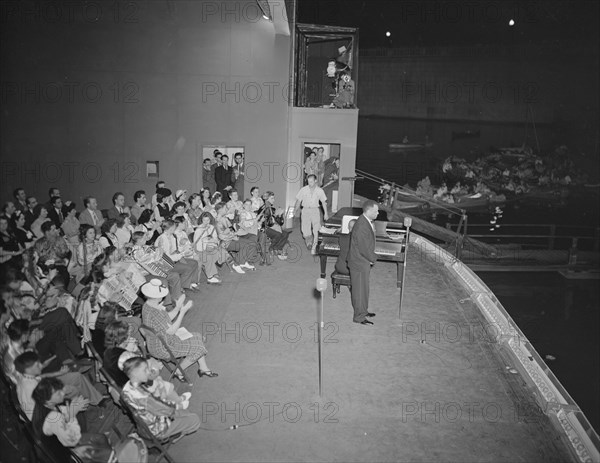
[141,279,219,379]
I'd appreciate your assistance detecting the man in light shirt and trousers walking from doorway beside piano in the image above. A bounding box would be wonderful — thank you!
[294,174,328,254]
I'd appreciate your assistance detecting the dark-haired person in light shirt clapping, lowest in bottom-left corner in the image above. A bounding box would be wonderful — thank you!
[32,378,113,463]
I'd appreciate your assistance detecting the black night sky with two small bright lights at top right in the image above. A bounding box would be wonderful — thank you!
[298,0,600,49]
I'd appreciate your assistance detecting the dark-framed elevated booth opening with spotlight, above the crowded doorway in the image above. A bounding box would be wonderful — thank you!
[294,24,358,109]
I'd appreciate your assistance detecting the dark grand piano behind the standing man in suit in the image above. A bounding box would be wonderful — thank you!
[317,207,407,288]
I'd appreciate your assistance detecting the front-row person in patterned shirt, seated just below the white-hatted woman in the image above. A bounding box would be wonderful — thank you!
[123,357,200,440]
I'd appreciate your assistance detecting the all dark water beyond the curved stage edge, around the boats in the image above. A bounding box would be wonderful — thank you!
[355,118,600,430]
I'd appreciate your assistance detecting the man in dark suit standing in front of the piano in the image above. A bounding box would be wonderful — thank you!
[348,200,379,325]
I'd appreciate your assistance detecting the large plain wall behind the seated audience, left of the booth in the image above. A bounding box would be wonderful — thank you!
[0,0,291,207]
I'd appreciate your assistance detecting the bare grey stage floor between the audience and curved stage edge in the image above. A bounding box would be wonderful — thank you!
[170,227,570,462]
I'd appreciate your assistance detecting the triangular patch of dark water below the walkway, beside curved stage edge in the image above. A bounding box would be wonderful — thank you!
[478,272,600,430]
